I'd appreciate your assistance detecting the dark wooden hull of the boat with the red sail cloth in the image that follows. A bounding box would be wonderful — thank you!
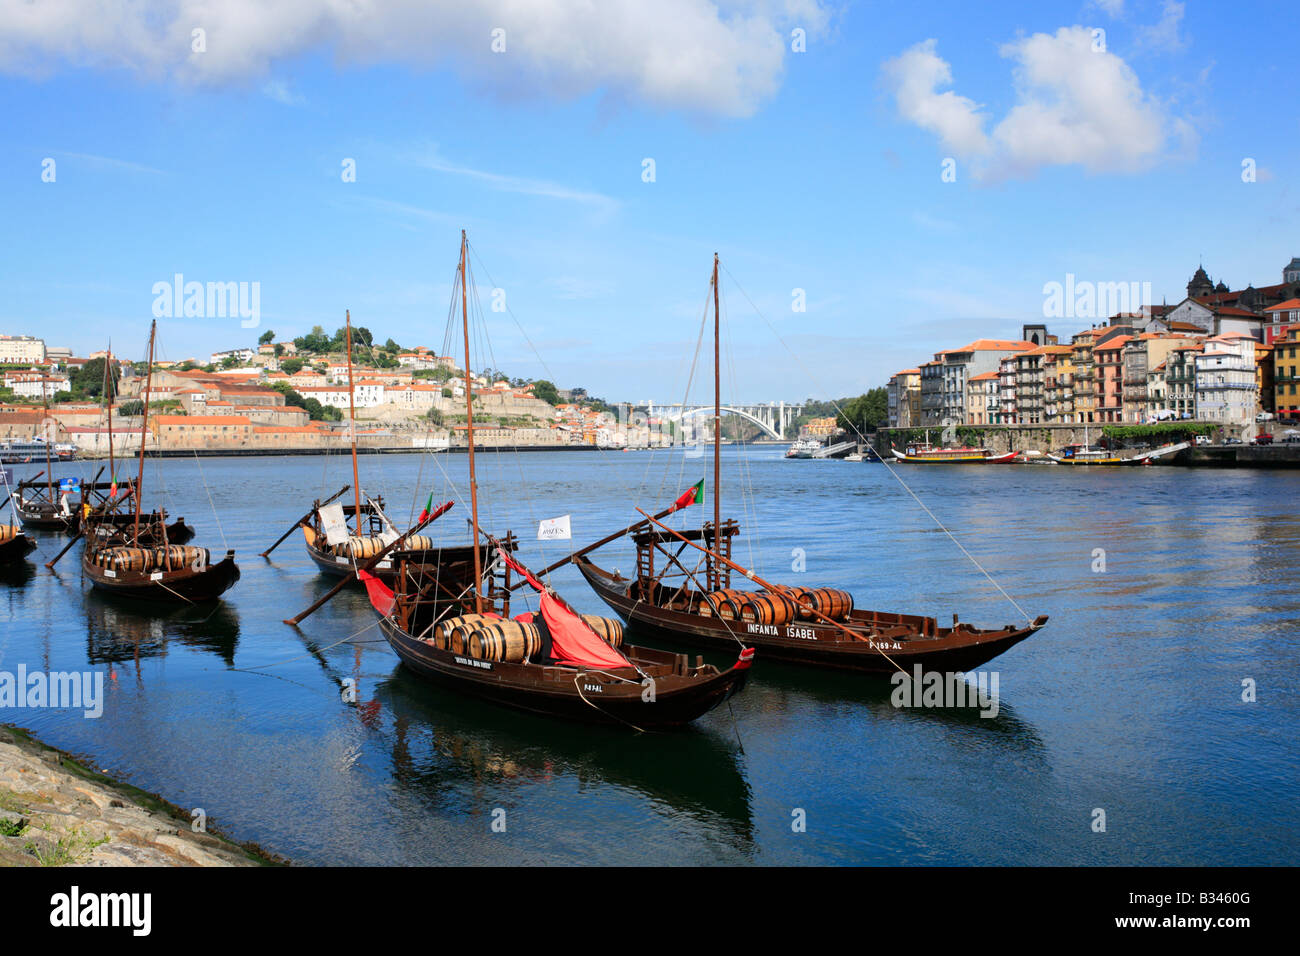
[381,617,749,730]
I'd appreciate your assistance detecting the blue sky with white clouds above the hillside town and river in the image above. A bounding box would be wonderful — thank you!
[0,0,1300,401]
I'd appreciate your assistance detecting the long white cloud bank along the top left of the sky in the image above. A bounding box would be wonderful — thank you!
[0,0,829,116]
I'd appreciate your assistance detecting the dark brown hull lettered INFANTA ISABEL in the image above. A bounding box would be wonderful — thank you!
[575,558,1047,675]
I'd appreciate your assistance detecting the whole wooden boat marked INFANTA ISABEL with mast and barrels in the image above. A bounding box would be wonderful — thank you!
[561,255,1047,674]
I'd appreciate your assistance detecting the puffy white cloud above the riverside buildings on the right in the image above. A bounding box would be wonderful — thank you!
[883,26,1193,178]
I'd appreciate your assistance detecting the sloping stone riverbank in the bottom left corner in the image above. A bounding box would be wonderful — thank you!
[0,723,276,866]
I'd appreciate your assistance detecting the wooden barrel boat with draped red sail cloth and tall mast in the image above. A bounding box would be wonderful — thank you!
[361,232,753,730]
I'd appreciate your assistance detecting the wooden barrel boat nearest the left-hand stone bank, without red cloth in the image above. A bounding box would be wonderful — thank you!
[76,321,239,604]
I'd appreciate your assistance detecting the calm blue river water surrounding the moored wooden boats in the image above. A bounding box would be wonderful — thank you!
[0,447,1300,864]
